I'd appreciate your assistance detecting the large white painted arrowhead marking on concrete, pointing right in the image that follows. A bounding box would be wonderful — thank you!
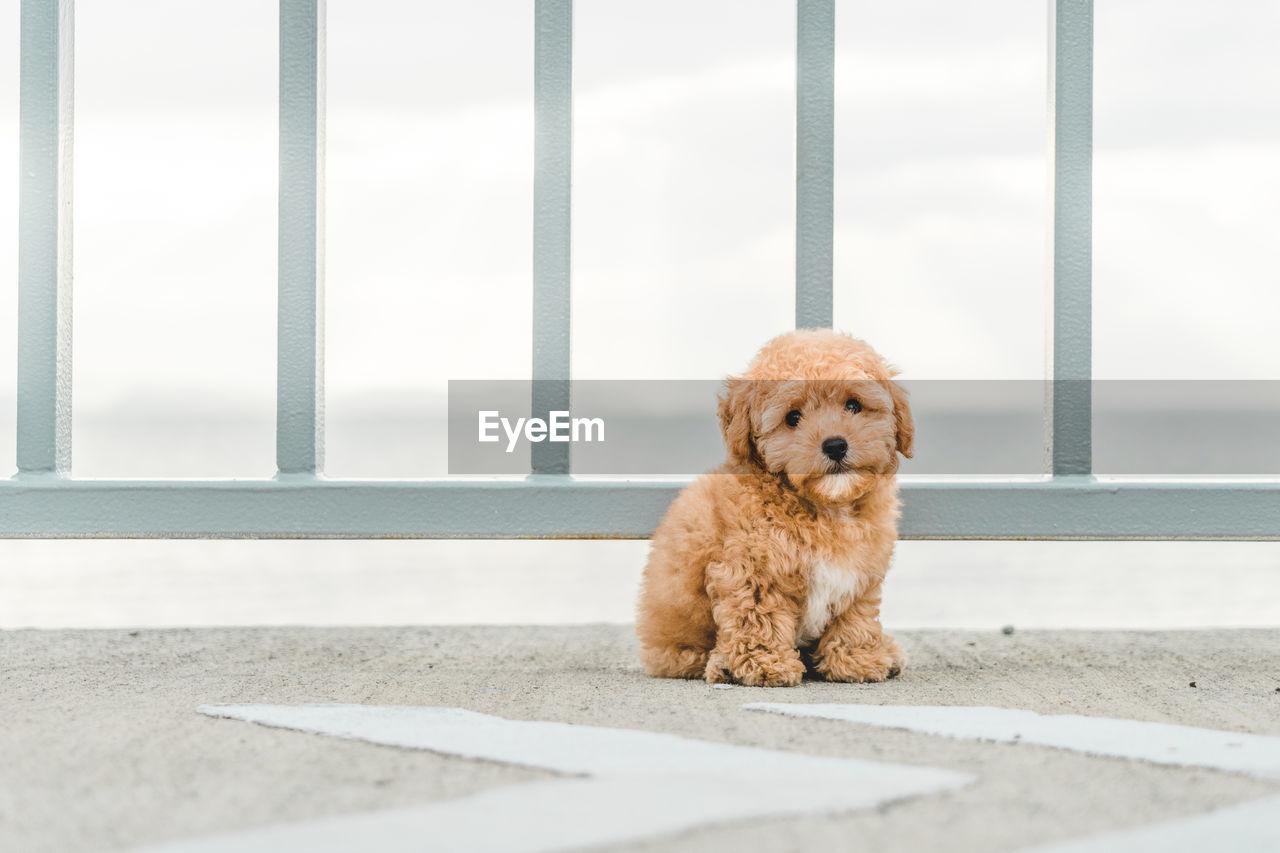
[142,704,973,853]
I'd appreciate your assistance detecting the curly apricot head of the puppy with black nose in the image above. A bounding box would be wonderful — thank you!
[719,329,915,503]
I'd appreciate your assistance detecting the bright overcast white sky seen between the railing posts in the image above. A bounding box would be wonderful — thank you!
[0,0,1280,420]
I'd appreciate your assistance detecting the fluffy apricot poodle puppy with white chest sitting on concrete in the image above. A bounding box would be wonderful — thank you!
[636,329,914,686]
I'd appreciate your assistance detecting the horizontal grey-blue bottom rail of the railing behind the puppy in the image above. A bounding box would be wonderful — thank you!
[0,475,1280,540]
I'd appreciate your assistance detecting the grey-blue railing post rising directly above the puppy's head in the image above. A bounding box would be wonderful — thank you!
[796,0,836,328]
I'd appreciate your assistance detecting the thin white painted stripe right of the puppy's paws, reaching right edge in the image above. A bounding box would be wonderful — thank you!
[742,702,1280,779]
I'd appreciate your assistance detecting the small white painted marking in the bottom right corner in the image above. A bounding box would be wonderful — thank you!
[1024,797,1280,853]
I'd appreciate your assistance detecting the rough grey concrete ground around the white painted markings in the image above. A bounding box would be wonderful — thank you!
[0,626,1280,853]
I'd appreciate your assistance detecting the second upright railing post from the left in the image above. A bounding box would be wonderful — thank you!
[275,0,325,474]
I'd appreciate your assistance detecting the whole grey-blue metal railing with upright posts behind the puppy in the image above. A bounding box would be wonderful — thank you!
[10,0,1280,539]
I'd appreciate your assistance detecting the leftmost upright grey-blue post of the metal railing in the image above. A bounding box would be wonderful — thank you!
[17,0,76,474]
